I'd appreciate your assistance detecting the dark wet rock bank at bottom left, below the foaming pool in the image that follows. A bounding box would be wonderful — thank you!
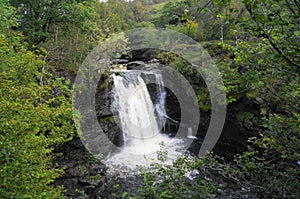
[53,137,142,199]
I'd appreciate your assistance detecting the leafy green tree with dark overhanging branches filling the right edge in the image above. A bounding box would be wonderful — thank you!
[211,0,300,198]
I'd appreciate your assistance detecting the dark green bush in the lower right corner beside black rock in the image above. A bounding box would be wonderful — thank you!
[226,114,300,198]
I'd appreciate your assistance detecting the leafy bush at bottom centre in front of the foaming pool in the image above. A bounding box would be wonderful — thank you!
[139,156,218,199]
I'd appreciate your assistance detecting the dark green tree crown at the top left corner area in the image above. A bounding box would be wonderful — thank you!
[9,0,94,44]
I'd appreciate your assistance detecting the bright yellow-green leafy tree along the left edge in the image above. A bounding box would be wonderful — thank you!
[0,0,74,198]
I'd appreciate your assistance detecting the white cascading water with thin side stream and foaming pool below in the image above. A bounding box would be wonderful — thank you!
[108,70,180,169]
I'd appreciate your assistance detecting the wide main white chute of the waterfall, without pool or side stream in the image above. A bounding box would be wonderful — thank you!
[113,71,164,150]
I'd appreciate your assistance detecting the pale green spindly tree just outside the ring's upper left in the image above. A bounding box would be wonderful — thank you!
[39,1,104,75]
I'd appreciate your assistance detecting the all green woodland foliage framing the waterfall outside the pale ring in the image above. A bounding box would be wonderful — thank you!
[0,0,300,198]
